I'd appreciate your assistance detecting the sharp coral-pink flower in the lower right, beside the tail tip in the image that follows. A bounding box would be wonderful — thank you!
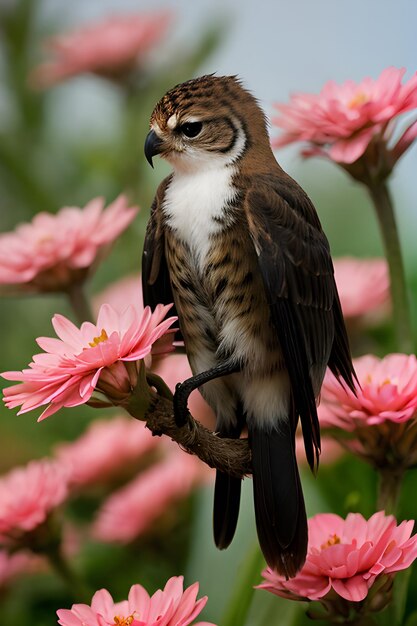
[259,511,417,605]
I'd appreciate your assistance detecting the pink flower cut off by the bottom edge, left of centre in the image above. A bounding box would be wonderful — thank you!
[57,576,214,626]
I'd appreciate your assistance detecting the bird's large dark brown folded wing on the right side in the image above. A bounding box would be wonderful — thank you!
[245,177,353,468]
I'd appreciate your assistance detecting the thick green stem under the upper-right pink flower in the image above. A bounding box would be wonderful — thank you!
[367,181,414,353]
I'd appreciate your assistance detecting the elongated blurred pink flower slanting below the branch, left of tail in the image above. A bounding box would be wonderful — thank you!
[93,449,211,543]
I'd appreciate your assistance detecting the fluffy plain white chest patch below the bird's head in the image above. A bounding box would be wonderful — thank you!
[163,167,236,263]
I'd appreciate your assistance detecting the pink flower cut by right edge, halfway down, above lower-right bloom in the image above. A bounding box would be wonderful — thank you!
[319,354,417,471]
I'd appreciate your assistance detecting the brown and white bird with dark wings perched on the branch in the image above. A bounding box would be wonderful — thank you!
[142,74,355,579]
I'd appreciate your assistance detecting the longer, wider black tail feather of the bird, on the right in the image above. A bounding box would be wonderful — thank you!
[249,420,308,578]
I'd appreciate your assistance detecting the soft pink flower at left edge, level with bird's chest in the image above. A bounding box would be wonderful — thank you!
[0,196,138,291]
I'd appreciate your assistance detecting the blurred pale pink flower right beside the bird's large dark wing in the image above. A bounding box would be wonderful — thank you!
[334,257,390,318]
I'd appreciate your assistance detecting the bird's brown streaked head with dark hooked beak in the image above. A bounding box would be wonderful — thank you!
[145,75,269,172]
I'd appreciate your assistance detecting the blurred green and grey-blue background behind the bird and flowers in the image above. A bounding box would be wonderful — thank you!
[0,0,417,626]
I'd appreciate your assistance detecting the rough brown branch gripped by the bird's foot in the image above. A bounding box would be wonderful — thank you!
[125,394,252,478]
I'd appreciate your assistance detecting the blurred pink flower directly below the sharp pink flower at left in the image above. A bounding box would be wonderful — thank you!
[55,416,158,487]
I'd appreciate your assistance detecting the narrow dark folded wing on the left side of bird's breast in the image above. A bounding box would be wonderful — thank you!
[142,177,181,340]
